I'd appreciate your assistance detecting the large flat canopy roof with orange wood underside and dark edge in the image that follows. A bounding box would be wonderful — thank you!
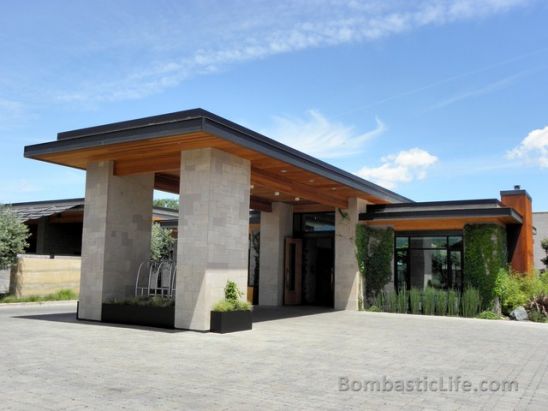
[24,109,411,208]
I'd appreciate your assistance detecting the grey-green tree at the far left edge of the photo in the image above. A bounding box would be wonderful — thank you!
[0,205,30,269]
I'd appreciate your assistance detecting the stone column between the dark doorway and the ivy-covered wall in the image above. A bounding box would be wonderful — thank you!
[334,198,367,310]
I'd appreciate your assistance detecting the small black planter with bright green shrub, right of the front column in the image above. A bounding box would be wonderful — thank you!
[210,281,252,334]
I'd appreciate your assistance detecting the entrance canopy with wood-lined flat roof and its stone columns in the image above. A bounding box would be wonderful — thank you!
[25,109,409,331]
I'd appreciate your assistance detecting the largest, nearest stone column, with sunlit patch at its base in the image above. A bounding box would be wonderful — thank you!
[175,148,251,331]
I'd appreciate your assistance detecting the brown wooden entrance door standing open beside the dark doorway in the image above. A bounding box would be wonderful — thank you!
[284,238,303,305]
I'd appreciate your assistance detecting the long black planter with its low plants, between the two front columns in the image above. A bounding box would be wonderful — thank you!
[101,296,175,328]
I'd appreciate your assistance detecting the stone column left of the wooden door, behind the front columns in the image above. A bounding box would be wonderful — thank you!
[259,203,293,305]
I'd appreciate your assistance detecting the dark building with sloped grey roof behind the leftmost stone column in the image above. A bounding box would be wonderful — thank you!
[9,198,178,256]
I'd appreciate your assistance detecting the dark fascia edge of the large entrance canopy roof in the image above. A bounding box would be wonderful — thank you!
[25,109,412,202]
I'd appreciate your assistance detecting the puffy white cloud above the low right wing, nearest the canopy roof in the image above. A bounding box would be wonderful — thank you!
[356,147,438,189]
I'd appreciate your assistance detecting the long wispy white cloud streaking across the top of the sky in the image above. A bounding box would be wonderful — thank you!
[53,0,529,102]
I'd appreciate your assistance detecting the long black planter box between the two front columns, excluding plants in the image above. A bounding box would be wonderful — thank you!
[101,304,175,328]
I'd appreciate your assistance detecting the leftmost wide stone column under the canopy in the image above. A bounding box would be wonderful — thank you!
[79,161,154,321]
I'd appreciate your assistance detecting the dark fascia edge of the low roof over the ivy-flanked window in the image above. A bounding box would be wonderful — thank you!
[360,207,523,224]
